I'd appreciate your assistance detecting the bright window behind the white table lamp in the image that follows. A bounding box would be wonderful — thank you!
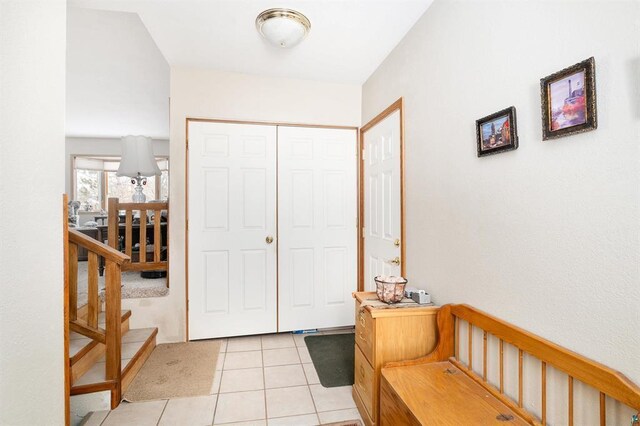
[73,156,169,212]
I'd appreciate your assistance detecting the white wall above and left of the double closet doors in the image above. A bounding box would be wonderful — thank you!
[123,68,361,341]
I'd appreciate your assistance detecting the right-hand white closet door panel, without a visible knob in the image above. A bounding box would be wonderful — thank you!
[278,127,358,331]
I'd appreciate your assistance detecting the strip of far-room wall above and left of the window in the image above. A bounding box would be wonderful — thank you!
[64,135,169,199]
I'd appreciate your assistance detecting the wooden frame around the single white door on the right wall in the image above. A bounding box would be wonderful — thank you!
[358,98,406,291]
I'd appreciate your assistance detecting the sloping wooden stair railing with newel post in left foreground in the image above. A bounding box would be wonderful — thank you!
[67,229,130,408]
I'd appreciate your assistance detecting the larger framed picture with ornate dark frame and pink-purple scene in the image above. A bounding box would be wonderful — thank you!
[540,58,598,140]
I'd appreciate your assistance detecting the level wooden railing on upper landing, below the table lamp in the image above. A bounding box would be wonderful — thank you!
[108,198,169,274]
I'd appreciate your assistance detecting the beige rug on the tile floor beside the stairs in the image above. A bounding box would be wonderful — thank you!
[124,341,220,402]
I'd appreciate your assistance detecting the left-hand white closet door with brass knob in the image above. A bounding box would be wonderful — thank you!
[188,122,277,339]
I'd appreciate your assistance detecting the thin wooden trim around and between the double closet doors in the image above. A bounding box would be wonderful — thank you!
[184,117,361,342]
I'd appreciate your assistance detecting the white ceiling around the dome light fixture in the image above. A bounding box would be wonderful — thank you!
[69,0,432,84]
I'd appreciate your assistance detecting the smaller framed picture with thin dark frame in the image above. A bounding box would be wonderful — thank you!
[476,107,518,157]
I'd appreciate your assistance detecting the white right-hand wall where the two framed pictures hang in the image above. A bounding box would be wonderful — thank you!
[362,1,640,410]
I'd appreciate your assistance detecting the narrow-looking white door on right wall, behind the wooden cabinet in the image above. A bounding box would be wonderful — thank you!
[363,111,402,291]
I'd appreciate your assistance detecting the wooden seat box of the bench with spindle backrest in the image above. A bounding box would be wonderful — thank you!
[380,361,528,426]
